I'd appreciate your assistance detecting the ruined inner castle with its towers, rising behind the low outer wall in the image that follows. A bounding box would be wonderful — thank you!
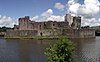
[14,14,81,30]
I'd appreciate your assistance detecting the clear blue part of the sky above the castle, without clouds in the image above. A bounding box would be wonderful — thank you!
[0,0,67,18]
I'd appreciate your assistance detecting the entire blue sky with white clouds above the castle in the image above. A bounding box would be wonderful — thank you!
[0,0,100,27]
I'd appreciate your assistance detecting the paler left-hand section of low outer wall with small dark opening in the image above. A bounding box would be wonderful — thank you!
[5,29,62,38]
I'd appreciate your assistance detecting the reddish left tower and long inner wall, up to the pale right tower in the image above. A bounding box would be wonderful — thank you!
[14,15,72,30]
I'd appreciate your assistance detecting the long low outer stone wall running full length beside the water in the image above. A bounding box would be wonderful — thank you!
[5,29,95,38]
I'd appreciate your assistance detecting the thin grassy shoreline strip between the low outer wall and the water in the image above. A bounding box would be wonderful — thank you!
[2,36,96,40]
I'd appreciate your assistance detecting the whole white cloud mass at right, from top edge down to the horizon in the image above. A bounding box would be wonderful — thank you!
[67,0,100,26]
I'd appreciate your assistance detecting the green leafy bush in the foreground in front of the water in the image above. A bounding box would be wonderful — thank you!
[45,37,75,62]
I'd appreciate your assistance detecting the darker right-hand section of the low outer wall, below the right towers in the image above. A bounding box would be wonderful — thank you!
[62,29,95,38]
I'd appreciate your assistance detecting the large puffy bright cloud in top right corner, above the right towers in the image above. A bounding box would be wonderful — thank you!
[67,0,100,18]
